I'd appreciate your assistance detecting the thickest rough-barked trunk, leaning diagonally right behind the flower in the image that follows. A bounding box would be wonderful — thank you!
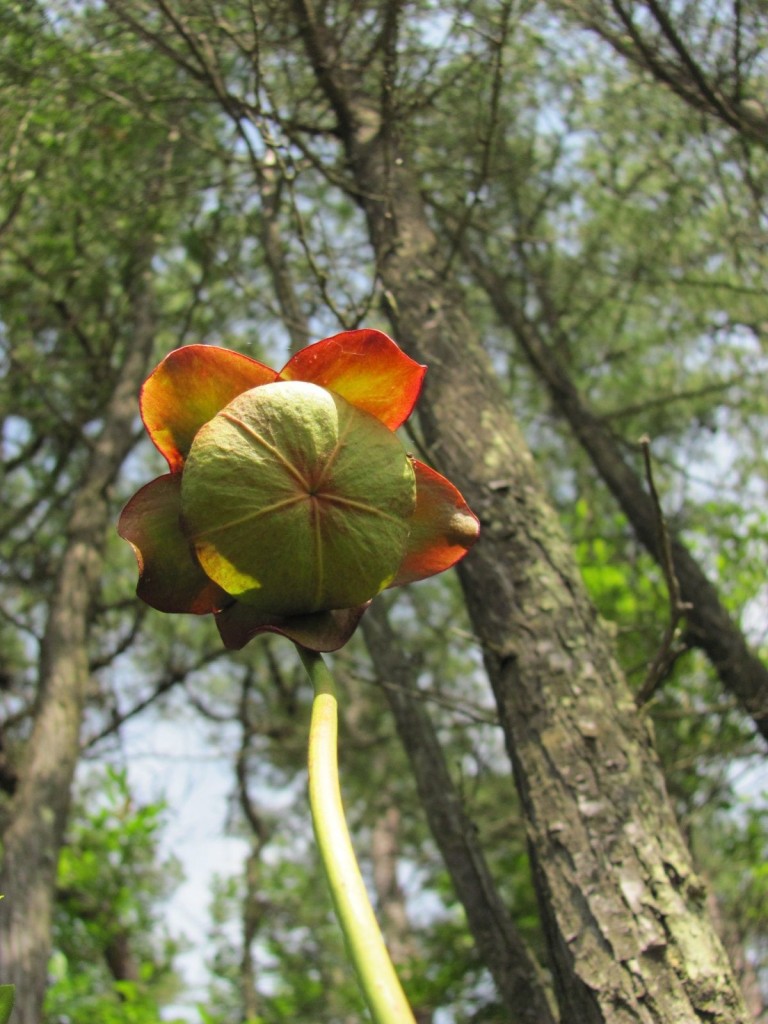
[293,0,746,1024]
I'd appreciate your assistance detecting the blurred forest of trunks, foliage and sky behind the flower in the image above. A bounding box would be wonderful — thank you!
[0,0,768,1024]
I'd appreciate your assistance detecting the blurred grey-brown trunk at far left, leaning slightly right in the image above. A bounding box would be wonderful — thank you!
[0,281,154,1024]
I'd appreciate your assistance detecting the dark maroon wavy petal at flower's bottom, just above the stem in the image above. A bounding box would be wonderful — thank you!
[211,601,371,653]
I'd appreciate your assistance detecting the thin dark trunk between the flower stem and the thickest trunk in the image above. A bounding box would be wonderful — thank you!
[362,603,555,1024]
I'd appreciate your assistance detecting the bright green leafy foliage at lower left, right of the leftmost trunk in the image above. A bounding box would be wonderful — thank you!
[45,768,184,1024]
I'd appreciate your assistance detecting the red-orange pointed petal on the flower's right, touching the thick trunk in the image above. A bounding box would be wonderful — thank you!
[390,459,480,587]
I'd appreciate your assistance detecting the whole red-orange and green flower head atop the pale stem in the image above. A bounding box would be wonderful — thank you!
[118,330,479,651]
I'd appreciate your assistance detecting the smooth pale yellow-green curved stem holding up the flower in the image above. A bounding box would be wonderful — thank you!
[296,644,415,1024]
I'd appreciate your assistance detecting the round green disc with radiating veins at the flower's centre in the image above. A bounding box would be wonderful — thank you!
[181,381,416,615]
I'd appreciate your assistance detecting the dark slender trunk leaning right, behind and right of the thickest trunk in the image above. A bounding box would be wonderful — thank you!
[470,255,768,739]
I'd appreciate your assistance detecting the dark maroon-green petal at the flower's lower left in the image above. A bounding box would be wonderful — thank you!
[118,473,230,615]
